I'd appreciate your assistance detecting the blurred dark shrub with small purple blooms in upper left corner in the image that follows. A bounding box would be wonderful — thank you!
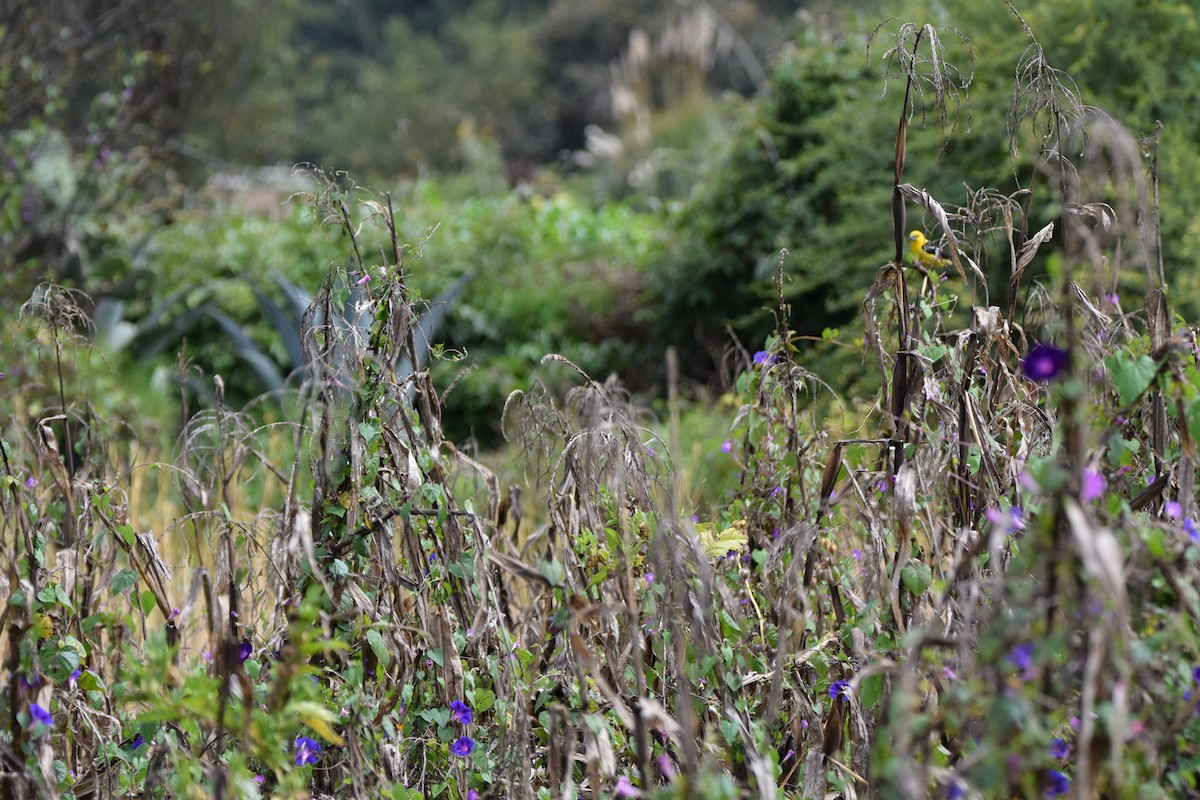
[0,0,287,302]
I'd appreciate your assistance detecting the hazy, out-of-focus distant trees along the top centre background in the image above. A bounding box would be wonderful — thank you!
[193,0,788,180]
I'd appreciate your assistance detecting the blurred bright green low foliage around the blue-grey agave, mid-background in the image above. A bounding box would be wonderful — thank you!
[118,182,661,441]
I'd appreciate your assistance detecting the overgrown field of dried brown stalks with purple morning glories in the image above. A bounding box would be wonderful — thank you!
[0,12,1200,800]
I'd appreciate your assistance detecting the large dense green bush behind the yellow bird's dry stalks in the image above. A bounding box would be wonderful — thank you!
[652,0,1200,378]
